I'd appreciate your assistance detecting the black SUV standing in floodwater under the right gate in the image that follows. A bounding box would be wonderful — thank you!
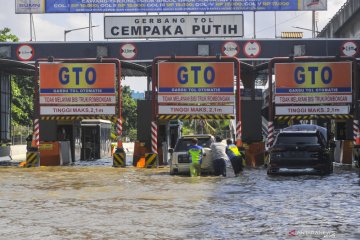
[267,126,333,175]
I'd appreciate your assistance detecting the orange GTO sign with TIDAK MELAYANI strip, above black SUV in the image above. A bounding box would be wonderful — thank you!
[275,62,352,105]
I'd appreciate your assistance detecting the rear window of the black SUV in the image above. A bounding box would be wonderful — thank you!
[275,133,319,145]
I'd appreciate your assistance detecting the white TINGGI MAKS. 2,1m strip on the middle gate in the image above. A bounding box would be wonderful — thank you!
[159,106,234,114]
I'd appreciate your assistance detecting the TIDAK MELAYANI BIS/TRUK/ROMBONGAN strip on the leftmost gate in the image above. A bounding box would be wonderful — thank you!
[40,96,116,105]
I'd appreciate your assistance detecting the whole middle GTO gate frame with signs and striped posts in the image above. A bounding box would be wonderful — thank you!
[146,56,242,166]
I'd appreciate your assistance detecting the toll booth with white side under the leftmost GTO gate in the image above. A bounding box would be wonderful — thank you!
[81,119,111,160]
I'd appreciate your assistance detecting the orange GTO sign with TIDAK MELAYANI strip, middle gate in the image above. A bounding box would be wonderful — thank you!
[158,62,235,105]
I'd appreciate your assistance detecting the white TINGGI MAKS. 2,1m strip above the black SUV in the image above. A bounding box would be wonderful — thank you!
[275,106,350,115]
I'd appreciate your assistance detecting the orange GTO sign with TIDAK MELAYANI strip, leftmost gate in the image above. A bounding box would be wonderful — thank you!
[40,63,116,106]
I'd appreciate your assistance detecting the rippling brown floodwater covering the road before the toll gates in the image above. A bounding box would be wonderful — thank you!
[0,159,360,239]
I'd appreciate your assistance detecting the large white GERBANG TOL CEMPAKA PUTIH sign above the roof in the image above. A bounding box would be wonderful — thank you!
[104,14,244,39]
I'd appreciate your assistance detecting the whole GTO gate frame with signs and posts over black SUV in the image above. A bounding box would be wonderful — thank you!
[267,56,360,164]
